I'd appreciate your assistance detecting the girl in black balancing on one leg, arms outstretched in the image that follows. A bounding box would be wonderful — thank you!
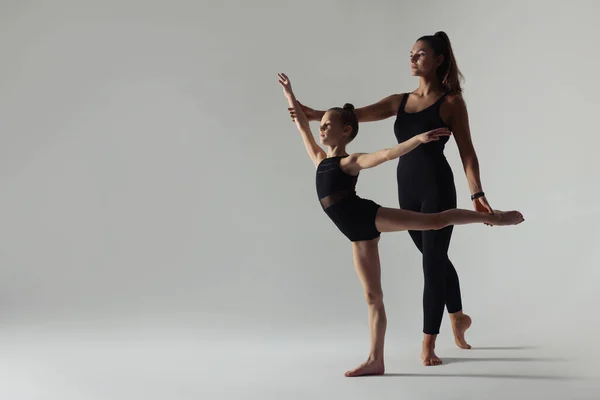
[279,74,523,376]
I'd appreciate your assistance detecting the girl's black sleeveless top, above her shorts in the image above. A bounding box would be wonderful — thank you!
[316,156,358,208]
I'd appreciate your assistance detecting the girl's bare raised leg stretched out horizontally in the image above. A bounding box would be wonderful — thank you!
[375,207,523,232]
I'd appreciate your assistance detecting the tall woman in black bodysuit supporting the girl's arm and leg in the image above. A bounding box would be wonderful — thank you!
[289,32,493,365]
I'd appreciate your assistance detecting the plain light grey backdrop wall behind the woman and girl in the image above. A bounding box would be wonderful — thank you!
[0,0,600,396]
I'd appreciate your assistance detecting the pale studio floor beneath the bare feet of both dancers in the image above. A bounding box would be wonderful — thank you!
[0,326,600,400]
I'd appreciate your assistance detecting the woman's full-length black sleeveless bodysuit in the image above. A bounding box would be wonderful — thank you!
[394,94,462,335]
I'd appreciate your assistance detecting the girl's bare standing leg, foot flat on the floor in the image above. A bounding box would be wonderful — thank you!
[346,238,387,377]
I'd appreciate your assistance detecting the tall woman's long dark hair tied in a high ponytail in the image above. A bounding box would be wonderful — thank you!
[419,31,463,94]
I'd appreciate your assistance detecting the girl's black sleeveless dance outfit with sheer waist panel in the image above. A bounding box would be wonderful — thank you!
[316,156,380,242]
